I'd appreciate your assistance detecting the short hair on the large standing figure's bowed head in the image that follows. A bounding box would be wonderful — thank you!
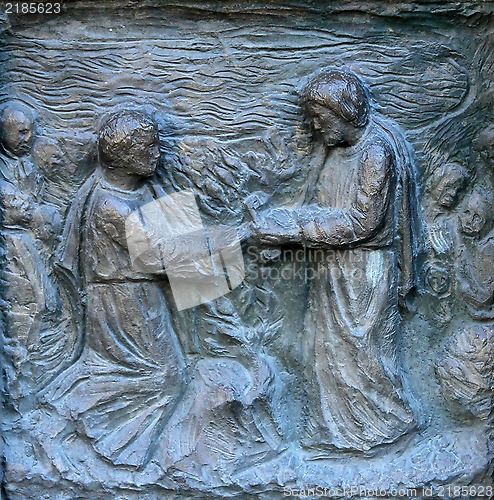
[301,69,370,128]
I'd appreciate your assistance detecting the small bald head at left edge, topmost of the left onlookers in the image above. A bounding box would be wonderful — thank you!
[0,101,34,156]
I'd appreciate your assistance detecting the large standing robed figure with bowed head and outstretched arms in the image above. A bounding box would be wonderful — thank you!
[251,70,417,451]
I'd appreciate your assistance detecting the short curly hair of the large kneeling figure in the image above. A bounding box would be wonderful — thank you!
[98,111,158,168]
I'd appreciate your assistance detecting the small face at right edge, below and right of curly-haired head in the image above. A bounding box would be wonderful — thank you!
[459,188,494,236]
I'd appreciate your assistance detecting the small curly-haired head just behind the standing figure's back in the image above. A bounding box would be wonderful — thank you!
[429,163,469,210]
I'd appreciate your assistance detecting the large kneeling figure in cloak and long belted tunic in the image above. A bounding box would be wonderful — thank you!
[43,111,186,467]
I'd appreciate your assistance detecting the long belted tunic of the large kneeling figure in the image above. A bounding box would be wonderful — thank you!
[46,179,186,467]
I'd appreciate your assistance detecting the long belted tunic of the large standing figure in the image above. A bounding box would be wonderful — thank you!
[299,125,414,451]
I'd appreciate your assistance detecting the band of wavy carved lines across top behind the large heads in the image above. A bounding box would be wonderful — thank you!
[0,25,466,145]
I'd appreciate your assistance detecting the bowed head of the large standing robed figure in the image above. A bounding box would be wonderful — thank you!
[302,70,370,147]
